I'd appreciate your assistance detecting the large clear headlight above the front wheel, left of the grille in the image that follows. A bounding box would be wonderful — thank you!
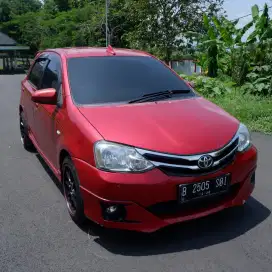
[94,141,154,172]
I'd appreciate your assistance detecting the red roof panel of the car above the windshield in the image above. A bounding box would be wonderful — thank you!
[40,46,151,58]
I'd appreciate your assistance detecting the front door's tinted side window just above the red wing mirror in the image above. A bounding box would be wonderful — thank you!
[41,54,61,92]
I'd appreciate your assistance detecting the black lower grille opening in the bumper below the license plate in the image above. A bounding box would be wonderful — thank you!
[147,183,241,218]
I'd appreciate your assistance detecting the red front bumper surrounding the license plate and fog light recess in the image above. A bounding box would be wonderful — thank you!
[73,146,257,232]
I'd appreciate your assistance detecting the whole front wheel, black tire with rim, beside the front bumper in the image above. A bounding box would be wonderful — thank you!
[61,157,86,225]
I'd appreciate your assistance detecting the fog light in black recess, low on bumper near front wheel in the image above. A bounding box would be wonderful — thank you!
[101,203,127,222]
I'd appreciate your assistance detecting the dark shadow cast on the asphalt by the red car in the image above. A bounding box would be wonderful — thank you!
[36,154,271,256]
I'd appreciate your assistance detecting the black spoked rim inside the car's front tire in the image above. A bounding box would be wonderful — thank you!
[63,167,77,215]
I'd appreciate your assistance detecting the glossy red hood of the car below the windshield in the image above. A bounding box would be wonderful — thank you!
[79,97,239,155]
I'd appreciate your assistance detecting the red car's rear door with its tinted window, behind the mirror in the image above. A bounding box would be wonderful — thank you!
[22,55,48,138]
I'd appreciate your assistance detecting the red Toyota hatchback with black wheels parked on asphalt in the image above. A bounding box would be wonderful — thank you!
[19,47,257,232]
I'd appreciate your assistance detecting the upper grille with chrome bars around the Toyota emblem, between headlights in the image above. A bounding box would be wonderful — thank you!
[137,135,239,176]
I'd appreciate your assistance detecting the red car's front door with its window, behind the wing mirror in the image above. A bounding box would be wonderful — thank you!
[34,53,63,169]
